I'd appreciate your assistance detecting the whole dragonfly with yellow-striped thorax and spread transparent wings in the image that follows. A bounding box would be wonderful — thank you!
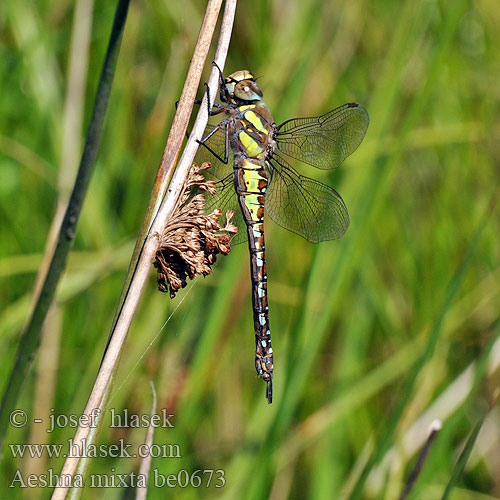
[195,69,370,404]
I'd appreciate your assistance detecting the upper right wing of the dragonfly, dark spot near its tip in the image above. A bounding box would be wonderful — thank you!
[276,103,370,169]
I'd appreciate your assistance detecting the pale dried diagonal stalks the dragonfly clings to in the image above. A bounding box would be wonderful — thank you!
[52,0,236,500]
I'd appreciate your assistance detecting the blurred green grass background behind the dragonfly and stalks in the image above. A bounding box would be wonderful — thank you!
[0,0,500,500]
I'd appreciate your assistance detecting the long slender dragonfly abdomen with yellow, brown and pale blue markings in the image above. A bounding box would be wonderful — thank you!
[234,158,273,403]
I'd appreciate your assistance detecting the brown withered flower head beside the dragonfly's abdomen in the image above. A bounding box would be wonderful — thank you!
[154,162,238,298]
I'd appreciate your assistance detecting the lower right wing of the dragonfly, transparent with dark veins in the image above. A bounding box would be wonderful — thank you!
[265,154,349,243]
